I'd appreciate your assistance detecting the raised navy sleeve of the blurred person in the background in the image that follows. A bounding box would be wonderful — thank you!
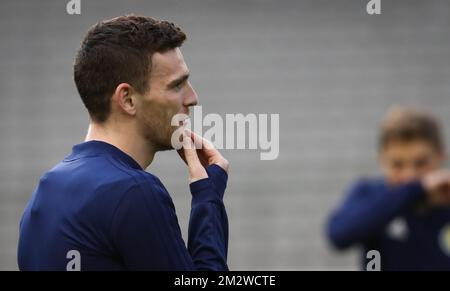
[327,182,425,249]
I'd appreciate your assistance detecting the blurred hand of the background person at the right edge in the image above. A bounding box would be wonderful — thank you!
[422,170,450,206]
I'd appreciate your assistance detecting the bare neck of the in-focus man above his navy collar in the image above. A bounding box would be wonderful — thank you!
[85,122,156,170]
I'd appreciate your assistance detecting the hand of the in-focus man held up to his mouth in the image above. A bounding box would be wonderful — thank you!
[178,130,229,183]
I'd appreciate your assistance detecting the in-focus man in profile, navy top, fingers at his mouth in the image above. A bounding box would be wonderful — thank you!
[18,15,228,270]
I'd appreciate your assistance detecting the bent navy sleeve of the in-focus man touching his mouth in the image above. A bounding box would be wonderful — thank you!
[111,167,228,271]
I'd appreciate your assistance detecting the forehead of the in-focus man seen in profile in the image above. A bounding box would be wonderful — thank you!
[151,48,188,77]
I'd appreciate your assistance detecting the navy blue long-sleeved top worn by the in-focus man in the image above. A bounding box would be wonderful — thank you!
[18,141,228,270]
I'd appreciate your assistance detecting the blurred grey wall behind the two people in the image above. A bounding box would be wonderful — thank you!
[0,0,450,270]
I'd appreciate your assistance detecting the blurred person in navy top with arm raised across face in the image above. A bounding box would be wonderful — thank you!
[327,107,450,270]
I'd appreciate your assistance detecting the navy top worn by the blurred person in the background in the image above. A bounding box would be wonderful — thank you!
[327,179,450,270]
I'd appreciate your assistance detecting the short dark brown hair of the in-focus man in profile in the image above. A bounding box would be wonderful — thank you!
[74,15,186,122]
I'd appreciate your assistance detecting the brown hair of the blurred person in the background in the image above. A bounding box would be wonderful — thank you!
[379,106,445,152]
